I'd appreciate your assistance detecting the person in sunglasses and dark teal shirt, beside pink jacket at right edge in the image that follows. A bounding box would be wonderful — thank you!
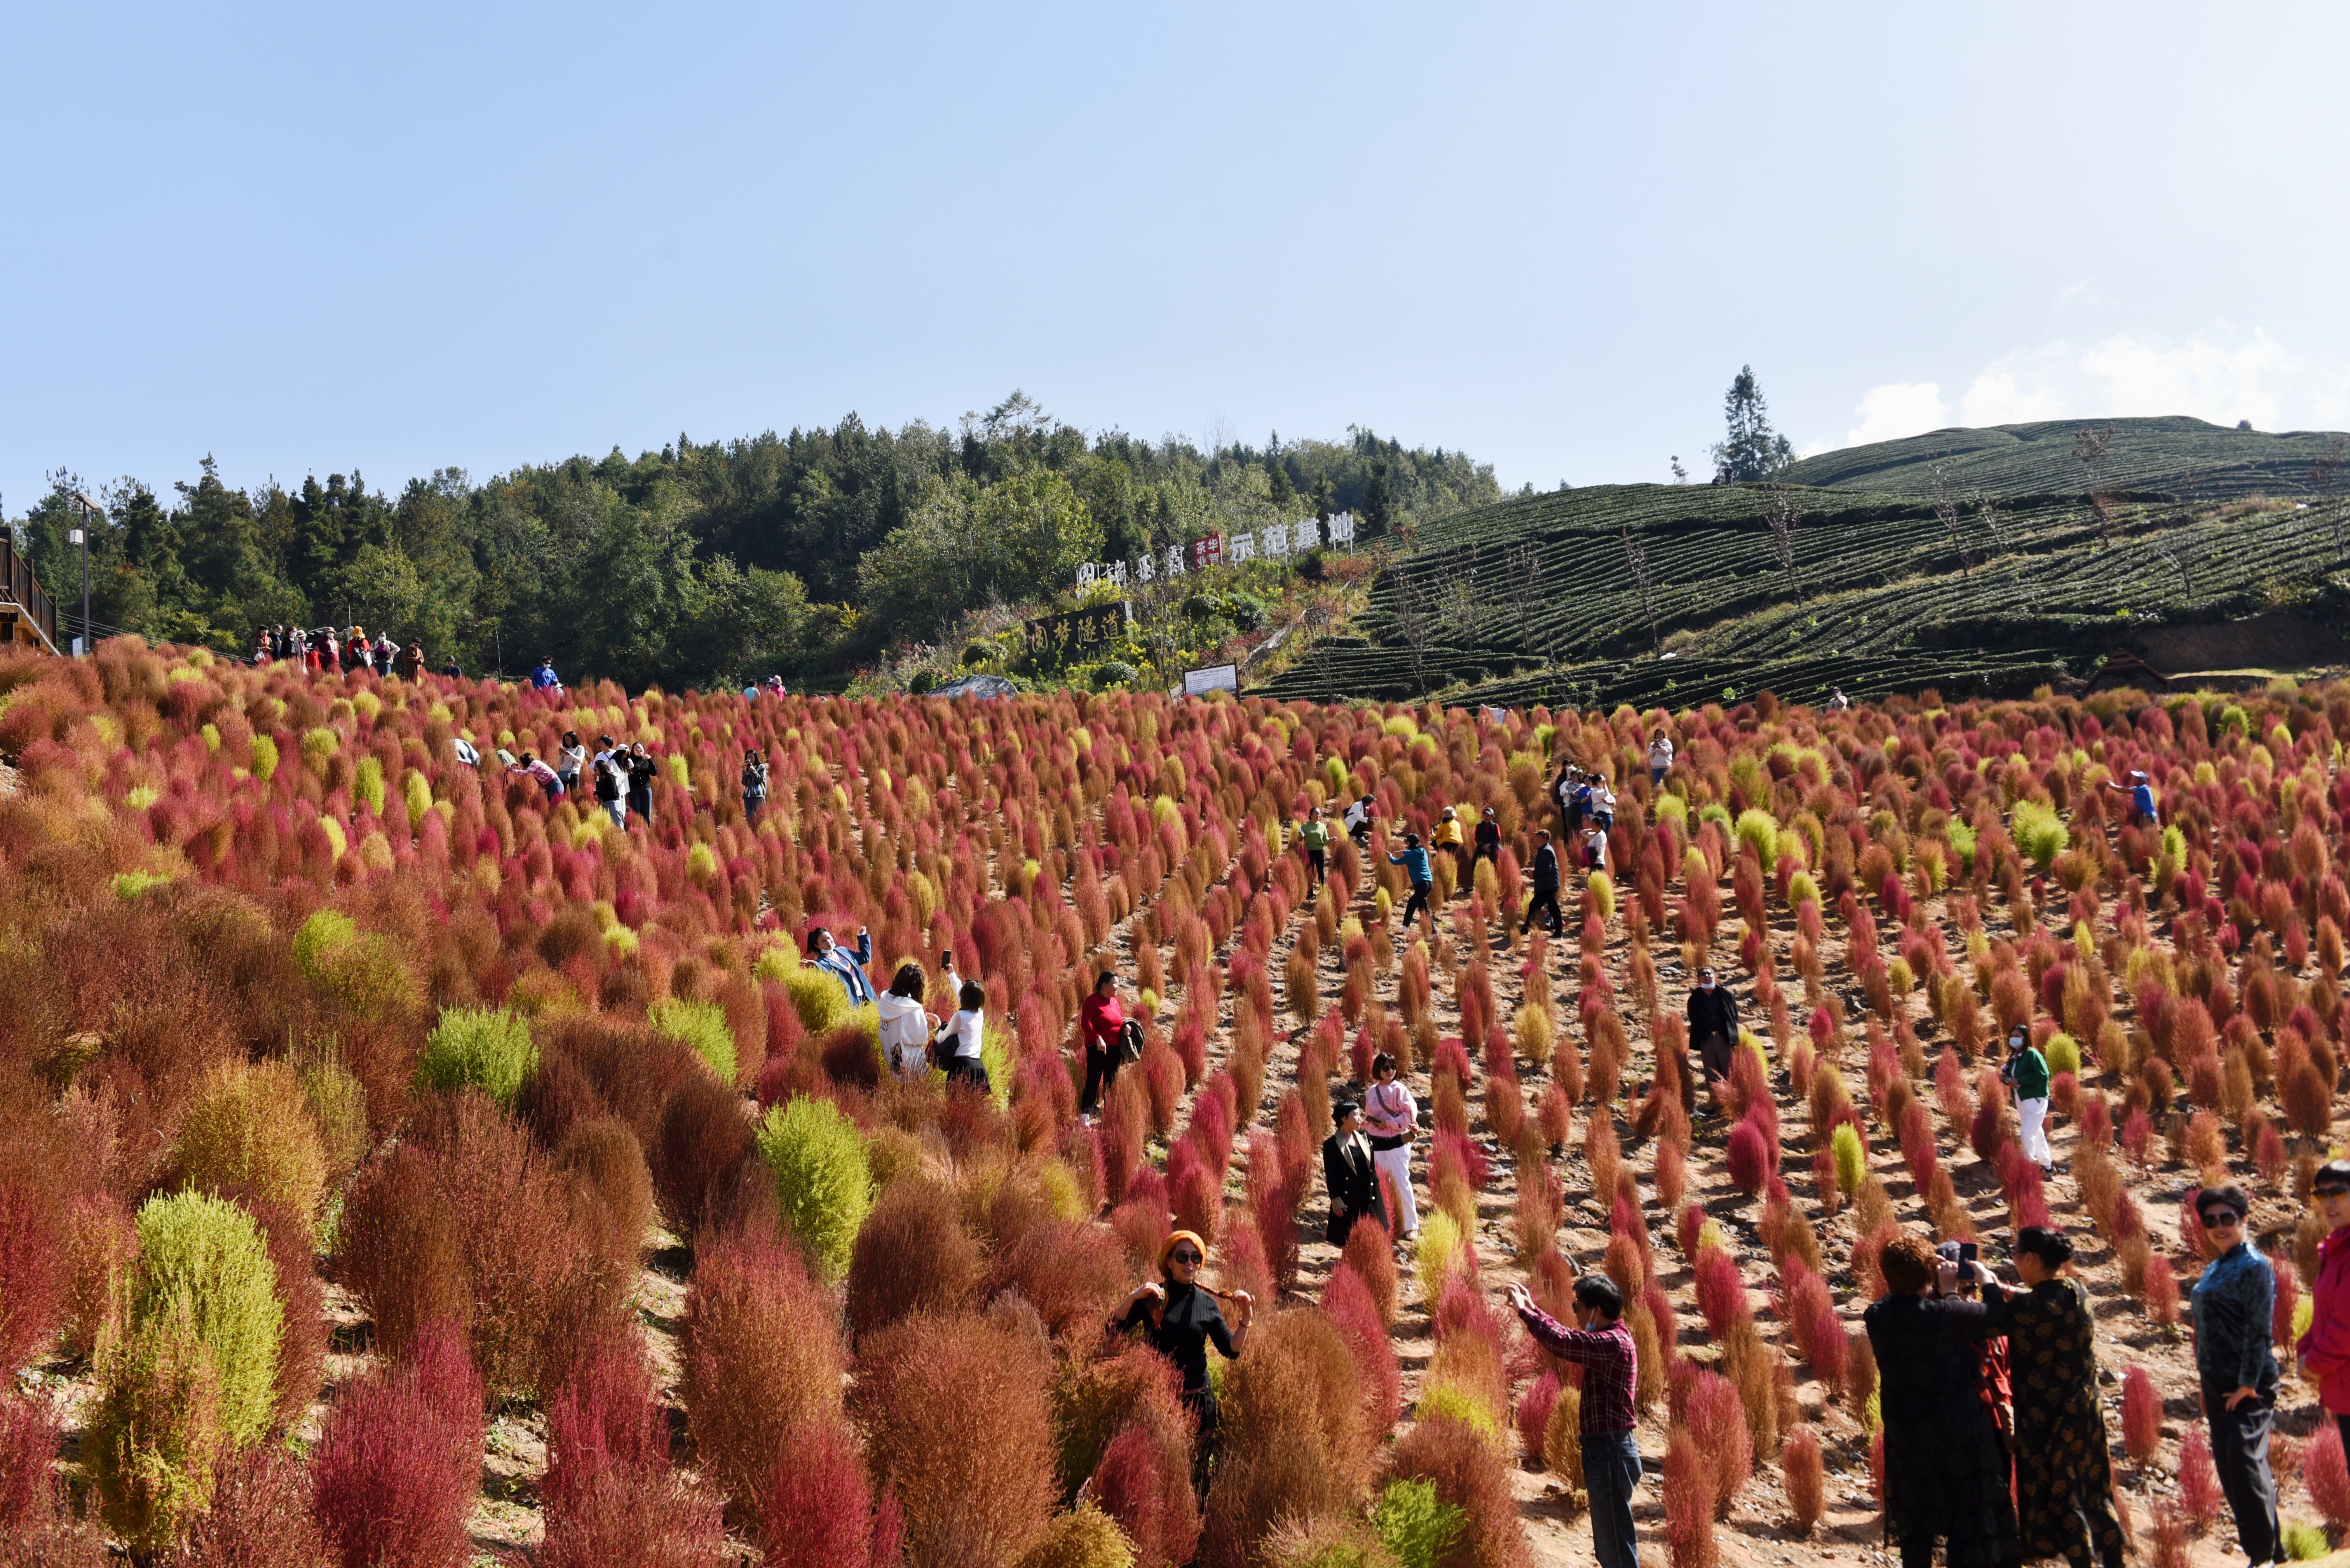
[2190,1182,2284,1566]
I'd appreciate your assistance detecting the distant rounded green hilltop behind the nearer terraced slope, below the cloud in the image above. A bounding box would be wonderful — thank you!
[1779,414,2345,501]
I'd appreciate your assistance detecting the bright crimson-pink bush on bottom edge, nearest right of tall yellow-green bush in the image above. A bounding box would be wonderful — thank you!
[310,1321,482,1568]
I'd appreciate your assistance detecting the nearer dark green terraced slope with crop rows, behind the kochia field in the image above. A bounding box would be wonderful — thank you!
[1262,472,2350,708]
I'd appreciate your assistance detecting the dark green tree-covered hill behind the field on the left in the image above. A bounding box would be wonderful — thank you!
[9,393,1499,687]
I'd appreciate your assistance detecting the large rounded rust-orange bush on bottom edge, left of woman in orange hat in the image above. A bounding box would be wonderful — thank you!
[851,1314,1057,1568]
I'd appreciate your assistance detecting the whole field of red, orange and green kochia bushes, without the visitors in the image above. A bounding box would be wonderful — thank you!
[0,639,2350,1568]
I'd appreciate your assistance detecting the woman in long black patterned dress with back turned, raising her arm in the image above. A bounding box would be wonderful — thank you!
[1983,1225,2122,1568]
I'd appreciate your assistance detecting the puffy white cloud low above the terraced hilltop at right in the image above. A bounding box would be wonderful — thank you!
[1960,327,2350,430]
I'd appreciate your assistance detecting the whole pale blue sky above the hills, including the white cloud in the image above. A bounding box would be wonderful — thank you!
[0,2,2350,513]
